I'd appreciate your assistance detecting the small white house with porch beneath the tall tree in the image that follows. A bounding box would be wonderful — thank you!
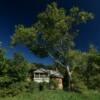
[33,68,63,89]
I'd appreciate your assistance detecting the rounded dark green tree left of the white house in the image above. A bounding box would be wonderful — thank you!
[10,54,30,81]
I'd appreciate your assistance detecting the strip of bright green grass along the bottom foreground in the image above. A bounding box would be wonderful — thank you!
[0,91,100,100]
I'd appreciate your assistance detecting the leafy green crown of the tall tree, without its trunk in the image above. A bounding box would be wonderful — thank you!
[12,2,93,56]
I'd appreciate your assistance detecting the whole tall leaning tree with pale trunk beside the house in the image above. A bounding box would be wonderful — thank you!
[12,2,93,89]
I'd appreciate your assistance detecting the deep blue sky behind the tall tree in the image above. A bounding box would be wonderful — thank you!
[0,0,100,64]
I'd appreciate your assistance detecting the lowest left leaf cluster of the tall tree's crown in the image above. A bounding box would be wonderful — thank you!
[11,25,37,46]
